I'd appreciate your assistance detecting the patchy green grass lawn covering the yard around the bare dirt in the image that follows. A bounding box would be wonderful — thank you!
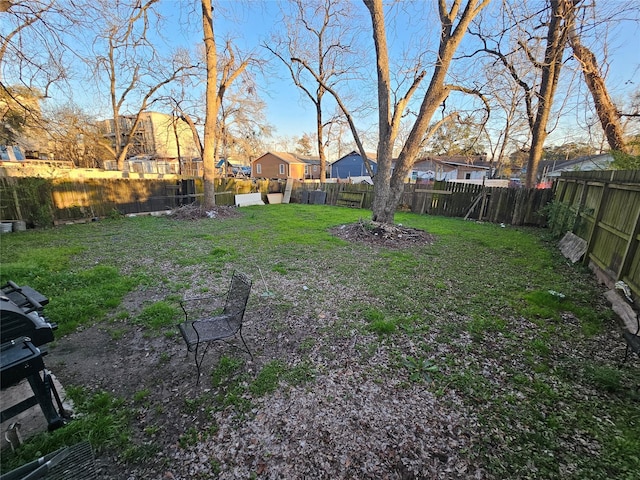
[0,204,640,479]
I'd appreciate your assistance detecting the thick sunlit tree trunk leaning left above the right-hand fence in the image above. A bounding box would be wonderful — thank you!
[569,26,627,153]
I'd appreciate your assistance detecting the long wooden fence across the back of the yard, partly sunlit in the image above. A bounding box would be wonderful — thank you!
[0,177,553,226]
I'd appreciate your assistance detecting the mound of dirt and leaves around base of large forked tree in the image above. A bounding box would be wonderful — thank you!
[331,219,435,248]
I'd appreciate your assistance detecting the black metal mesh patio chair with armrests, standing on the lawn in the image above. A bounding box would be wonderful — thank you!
[178,272,253,384]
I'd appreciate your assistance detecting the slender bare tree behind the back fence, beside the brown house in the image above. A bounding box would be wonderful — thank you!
[263,0,364,181]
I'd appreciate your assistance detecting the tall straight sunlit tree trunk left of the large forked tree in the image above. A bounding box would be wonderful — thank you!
[201,0,218,208]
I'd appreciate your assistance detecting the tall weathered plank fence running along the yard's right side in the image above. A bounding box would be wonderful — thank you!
[555,170,640,296]
